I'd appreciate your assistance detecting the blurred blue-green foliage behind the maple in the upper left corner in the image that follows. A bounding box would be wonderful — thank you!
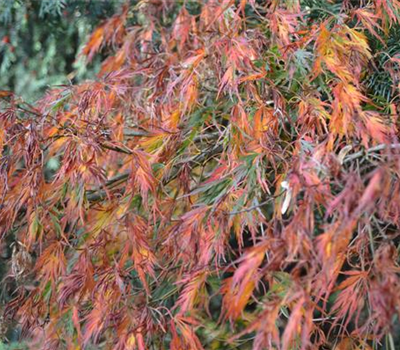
[0,0,124,103]
